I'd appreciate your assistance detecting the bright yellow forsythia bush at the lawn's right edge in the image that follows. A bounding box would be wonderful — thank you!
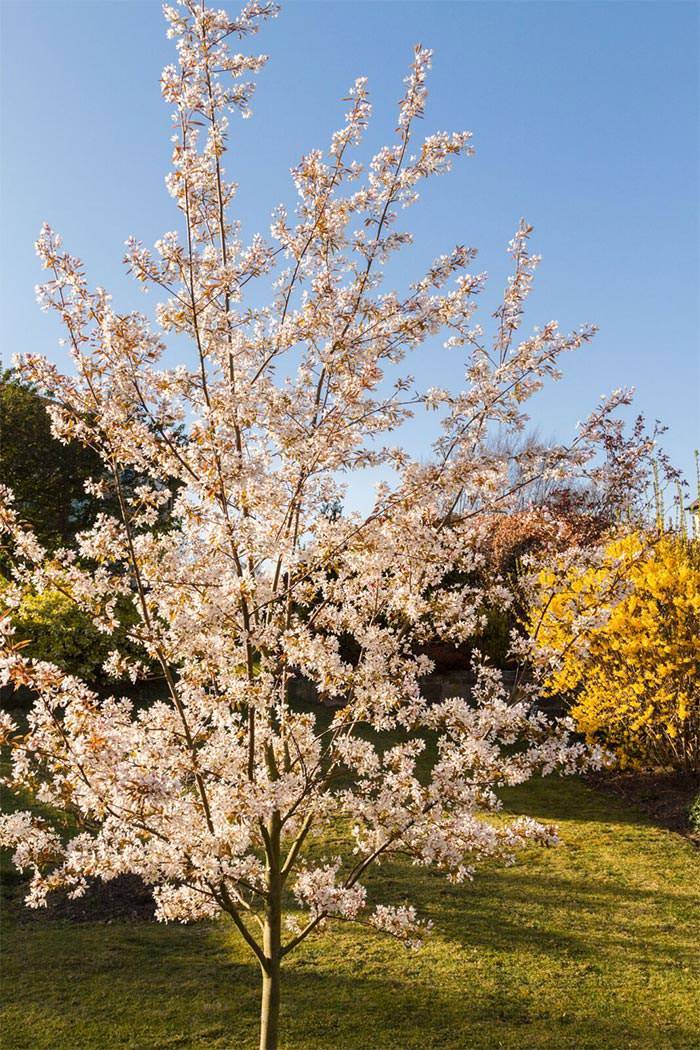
[529,532,700,773]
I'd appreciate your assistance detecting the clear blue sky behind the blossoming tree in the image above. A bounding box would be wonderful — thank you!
[0,0,700,495]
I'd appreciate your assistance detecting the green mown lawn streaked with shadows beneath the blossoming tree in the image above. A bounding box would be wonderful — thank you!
[0,780,700,1050]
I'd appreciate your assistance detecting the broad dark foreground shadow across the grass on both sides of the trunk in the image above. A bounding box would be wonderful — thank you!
[2,911,697,1050]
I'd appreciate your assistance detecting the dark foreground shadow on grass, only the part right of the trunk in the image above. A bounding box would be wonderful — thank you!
[277,968,697,1050]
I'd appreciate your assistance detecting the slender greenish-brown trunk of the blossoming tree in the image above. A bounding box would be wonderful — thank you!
[260,813,282,1050]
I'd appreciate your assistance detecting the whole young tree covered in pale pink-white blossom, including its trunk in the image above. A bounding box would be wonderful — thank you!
[2,0,650,1050]
